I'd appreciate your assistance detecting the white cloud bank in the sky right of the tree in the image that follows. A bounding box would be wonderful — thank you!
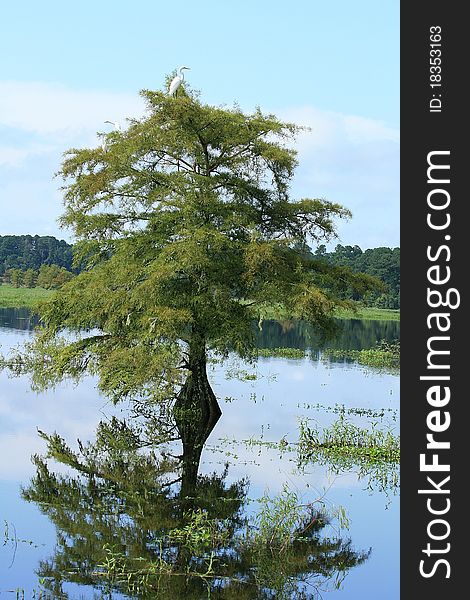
[277,106,400,249]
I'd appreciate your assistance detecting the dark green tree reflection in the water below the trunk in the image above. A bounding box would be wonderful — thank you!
[23,406,369,599]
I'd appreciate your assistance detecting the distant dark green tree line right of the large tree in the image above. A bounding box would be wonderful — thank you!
[310,244,400,308]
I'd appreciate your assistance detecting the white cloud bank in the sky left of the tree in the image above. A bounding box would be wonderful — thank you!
[0,81,144,237]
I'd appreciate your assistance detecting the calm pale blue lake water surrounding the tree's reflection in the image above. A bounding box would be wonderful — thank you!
[0,309,399,600]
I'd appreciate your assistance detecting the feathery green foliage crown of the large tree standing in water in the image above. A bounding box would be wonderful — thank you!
[6,78,377,402]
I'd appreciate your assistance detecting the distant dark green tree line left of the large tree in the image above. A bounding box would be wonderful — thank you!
[0,235,78,277]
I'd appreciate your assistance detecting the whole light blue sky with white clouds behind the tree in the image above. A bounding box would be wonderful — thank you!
[0,0,400,249]
